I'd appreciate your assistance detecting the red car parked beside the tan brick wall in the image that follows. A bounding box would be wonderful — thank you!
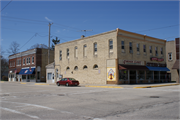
[56,78,79,86]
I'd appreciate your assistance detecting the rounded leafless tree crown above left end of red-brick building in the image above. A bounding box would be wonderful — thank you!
[7,41,20,54]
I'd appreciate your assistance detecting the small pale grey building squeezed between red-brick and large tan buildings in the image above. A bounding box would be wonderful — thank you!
[46,62,54,83]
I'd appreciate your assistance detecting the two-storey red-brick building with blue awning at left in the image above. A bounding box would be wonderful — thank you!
[8,48,54,82]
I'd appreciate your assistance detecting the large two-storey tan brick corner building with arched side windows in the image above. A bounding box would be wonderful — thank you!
[55,29,169,84]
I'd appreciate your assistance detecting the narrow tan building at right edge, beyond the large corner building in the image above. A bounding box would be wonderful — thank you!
[166,40,179,81]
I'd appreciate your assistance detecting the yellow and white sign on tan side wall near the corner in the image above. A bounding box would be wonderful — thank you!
[107,68,116,81]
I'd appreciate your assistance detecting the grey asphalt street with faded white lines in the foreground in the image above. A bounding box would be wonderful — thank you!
[0,82,180,120]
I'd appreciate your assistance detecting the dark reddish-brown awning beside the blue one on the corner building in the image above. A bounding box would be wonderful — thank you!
[119,64,149,70]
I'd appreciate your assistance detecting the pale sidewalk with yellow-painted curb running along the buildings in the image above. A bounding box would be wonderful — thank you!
[1,81,180,89]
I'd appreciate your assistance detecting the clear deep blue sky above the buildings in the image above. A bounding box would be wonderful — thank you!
[1,0,179,56]
